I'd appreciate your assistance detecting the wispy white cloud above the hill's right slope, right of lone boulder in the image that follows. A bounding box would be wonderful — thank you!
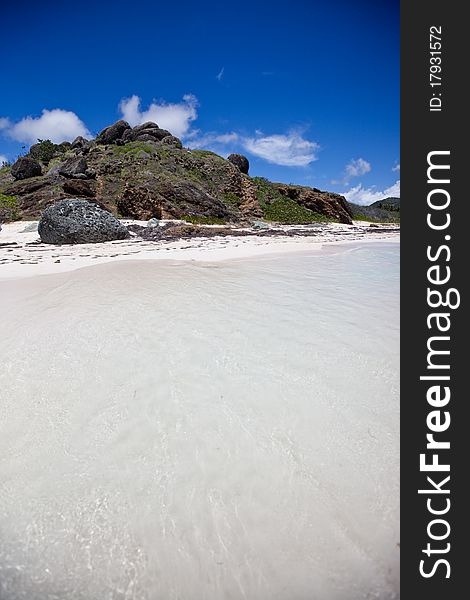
[242,131,320,167]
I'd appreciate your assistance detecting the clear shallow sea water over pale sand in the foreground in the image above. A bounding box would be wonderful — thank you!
[0,243,400,600]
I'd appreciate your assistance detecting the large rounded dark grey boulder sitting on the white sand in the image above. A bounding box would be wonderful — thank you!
[38,198,129,245]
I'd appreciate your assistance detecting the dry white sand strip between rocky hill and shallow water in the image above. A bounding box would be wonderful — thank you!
[0,221,398,280]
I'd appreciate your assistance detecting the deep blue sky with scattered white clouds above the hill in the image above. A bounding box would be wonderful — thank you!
[0,0,400,203]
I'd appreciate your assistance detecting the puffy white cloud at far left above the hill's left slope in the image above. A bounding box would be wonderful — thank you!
[2,108,91,144]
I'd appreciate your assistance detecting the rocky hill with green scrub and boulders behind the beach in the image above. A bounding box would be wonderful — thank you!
[0,121,352,223]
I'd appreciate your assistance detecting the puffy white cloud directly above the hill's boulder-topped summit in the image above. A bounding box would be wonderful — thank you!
[119,94,198,137]
